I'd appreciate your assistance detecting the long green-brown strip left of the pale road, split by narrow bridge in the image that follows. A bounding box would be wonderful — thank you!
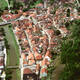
[0,25,20,80]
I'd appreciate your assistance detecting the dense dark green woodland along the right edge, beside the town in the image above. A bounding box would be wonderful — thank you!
[60,20,80,80]
